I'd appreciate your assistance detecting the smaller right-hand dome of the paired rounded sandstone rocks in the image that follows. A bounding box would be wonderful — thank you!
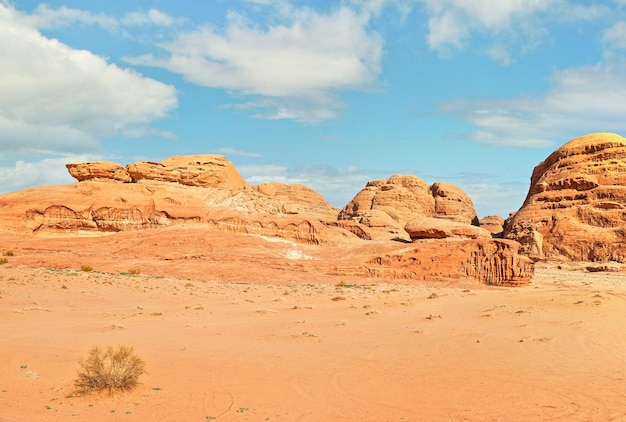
[430,182,478,226]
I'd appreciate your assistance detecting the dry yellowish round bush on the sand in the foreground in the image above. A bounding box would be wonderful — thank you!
[74,346,145,394]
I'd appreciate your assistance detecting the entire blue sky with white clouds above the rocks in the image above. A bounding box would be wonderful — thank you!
[0,0,626,217]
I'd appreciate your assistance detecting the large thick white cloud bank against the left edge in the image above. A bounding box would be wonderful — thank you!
[0,4,177,154]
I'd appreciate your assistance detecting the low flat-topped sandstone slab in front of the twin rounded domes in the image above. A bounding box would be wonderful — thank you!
[404,217,491,240]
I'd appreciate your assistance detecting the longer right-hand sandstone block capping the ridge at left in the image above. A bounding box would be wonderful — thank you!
[126,154,247,191]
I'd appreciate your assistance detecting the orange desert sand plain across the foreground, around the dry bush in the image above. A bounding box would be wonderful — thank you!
[0,228,626,422]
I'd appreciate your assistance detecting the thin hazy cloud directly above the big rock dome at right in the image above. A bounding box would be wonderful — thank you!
[440,62,626,148]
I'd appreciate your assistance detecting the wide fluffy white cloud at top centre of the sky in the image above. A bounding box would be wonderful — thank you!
[127,3,382,121]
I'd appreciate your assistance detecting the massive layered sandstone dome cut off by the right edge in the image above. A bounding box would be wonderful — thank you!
[504,133,626,262]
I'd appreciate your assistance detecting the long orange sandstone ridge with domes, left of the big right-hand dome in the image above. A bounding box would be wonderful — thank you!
[0,155,533,285]
